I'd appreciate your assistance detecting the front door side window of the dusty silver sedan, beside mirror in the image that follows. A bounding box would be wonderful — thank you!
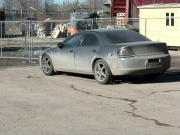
[63,34,83,47]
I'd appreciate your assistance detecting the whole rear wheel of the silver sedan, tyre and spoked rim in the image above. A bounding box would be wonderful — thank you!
[93,59,113,84]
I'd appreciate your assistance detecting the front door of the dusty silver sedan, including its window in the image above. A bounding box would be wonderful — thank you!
[54,33,83,71]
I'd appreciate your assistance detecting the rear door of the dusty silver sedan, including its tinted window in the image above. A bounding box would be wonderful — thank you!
[75,32,100,73]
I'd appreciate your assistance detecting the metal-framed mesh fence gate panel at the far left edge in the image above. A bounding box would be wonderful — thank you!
[0,21,32,59]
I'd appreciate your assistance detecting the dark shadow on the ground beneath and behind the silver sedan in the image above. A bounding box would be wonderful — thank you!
[56,71,180,84]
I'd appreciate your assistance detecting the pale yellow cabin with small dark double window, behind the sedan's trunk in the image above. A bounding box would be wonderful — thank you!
[138,3,180,48]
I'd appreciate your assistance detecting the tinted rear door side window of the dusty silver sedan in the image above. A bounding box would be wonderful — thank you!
[81,33,99,46]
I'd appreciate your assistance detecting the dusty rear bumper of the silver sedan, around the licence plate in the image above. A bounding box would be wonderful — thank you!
[108,54,171,75]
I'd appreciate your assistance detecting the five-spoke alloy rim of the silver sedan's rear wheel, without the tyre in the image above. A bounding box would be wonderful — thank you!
[95,63,106,82]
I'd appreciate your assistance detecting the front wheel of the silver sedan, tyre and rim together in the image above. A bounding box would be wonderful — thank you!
[41,54,55,76]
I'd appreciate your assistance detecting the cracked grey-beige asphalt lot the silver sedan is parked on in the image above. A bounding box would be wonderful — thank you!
[0,52,180,135]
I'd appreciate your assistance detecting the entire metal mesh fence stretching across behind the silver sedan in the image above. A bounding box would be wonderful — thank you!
[0,18,180,62]
